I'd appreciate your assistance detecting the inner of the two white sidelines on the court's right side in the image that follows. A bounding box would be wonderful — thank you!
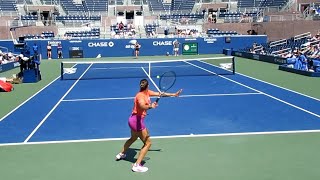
[185,61,320,118]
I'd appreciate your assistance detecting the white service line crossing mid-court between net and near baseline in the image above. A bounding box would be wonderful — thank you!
[62,93,262,102]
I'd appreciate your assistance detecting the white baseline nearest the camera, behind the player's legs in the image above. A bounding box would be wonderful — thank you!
[0,129,320,147]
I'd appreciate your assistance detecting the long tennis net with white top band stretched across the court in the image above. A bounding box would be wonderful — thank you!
[61,56,235,80]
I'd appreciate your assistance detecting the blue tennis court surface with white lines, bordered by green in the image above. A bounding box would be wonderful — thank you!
[0,59,320,145]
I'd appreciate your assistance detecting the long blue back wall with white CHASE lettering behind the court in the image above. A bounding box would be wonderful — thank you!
[0,35,267,59]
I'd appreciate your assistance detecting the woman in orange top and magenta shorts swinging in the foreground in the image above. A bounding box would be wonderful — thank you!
[116,79,182,172]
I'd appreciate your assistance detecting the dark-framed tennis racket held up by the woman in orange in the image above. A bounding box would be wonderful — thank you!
[156,71,176,103]
